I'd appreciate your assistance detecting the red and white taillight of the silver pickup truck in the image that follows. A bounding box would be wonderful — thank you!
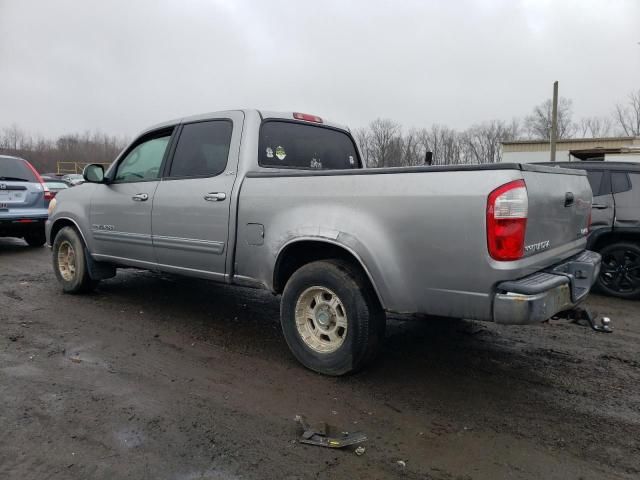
[487,180,529,260]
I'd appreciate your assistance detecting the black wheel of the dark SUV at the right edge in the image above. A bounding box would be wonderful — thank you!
[596,242,640,299]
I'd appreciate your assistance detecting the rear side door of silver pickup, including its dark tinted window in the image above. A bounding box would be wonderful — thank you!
[152,112,244,278]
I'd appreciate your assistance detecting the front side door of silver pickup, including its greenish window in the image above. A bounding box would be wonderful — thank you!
[90,129,172,266]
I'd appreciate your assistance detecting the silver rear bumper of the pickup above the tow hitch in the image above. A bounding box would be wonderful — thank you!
[493,250,601,325]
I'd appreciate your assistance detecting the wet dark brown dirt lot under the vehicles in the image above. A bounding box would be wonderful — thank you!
[0,239,640,480]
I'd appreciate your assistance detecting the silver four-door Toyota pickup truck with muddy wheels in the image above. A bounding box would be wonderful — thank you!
[46,110,600,375]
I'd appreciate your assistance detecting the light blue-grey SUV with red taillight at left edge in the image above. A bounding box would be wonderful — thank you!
[0,155,54,247]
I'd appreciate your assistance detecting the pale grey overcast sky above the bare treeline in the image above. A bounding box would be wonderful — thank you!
[0,0,640,136]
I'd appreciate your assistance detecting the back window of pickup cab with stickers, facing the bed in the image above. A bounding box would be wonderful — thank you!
[258,121,360,170]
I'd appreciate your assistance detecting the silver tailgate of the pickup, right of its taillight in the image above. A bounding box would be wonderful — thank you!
[522,165,592,257]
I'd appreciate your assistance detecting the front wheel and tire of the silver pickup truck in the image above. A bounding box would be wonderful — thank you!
[52,227,98,293]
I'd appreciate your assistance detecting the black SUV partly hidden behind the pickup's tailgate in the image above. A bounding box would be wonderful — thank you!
[545,161,640,298]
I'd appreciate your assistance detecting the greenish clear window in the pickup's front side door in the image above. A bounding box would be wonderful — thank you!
[113,133,171,183]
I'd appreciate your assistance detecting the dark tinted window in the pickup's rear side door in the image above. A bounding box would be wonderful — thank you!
[168,120,233,178]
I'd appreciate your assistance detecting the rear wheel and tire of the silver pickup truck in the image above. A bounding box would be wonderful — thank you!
[280,260,386,376]
